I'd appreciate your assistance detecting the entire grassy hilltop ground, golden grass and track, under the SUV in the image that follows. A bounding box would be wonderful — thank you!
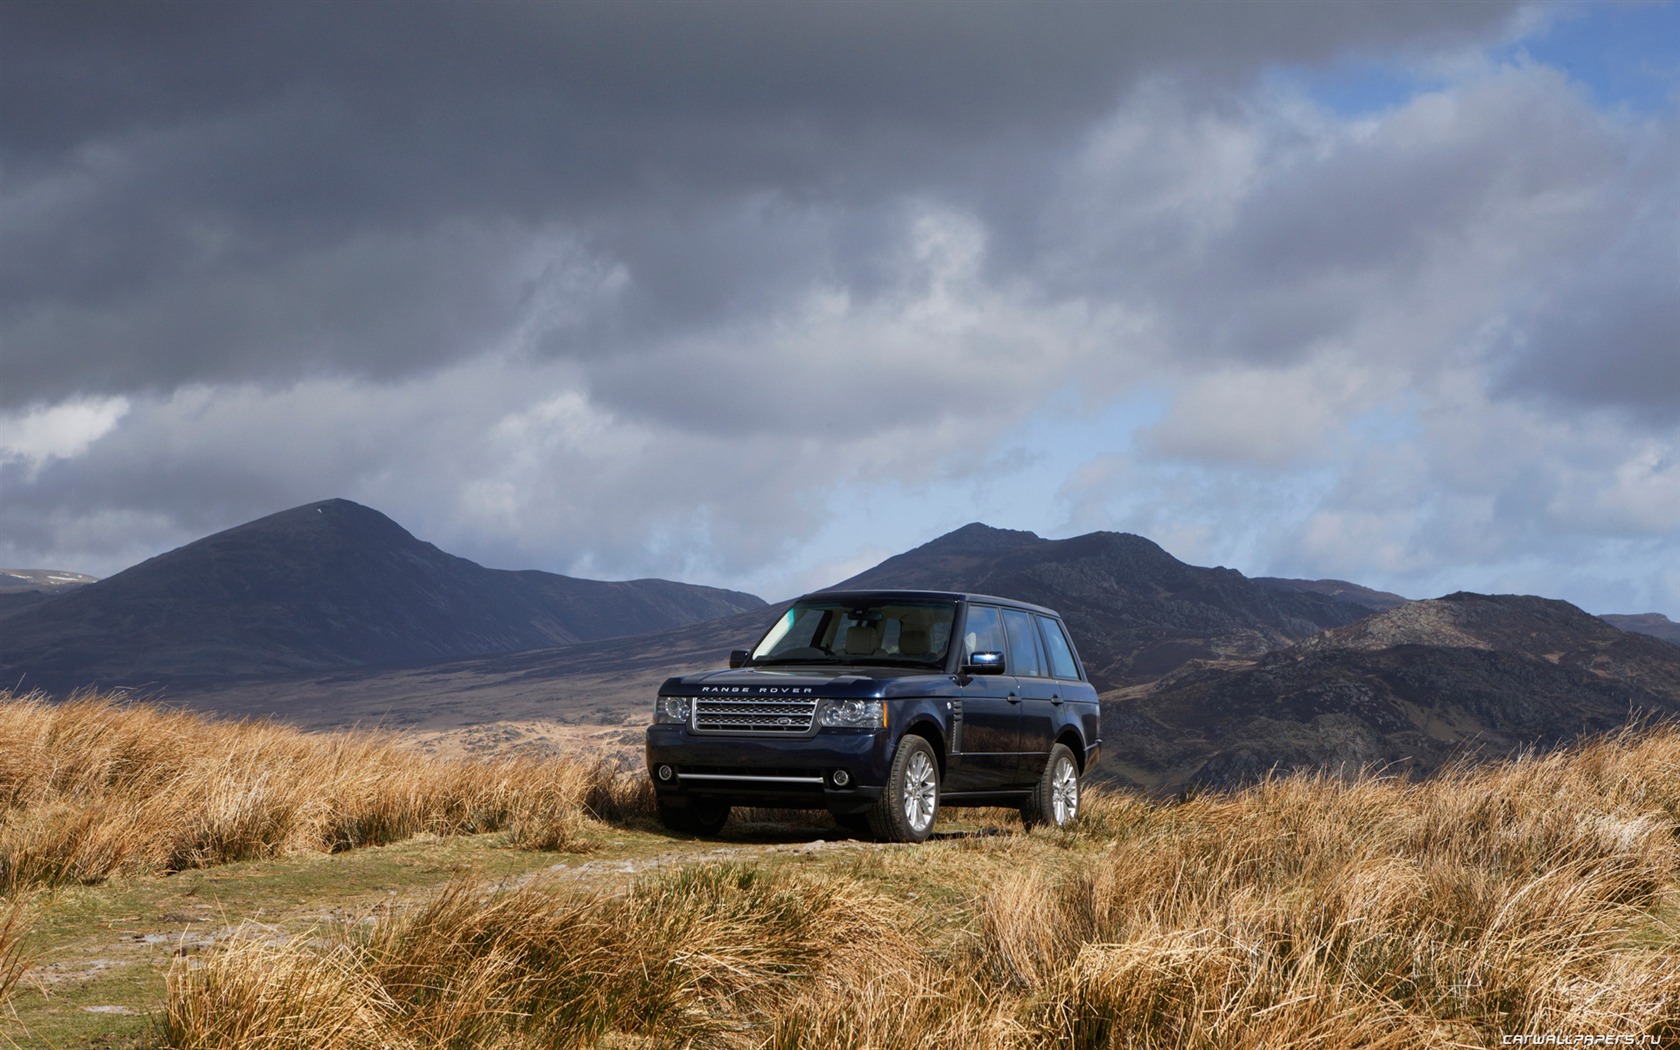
[0,697,1680,1050]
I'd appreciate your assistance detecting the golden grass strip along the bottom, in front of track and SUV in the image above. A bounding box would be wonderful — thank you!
[166,729,1680,1050]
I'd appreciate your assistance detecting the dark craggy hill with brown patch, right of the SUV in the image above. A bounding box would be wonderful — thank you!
[1104,593,1680,790]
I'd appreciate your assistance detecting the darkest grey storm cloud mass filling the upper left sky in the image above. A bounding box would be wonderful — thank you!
[0,3,1507,407]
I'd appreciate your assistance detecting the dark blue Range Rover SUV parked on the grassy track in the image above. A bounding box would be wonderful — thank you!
[647,591,1102,842]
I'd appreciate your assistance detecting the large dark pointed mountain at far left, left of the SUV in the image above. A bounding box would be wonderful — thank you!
[0,499,764,692]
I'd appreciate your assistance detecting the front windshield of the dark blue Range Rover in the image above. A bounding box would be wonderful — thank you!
[753,598,956,667]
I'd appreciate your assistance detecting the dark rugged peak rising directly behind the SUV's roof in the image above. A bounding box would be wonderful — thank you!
[835,522,1371,689]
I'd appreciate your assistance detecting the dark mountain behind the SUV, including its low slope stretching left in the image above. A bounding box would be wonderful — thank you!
[180,524,1369,726]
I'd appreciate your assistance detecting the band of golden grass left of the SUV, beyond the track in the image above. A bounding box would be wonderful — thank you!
[0,692,652,894]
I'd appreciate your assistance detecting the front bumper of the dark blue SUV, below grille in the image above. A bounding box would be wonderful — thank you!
[647,724,892,813]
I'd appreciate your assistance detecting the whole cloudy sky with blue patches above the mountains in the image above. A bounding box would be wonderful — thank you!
[0,0,1680,620]
